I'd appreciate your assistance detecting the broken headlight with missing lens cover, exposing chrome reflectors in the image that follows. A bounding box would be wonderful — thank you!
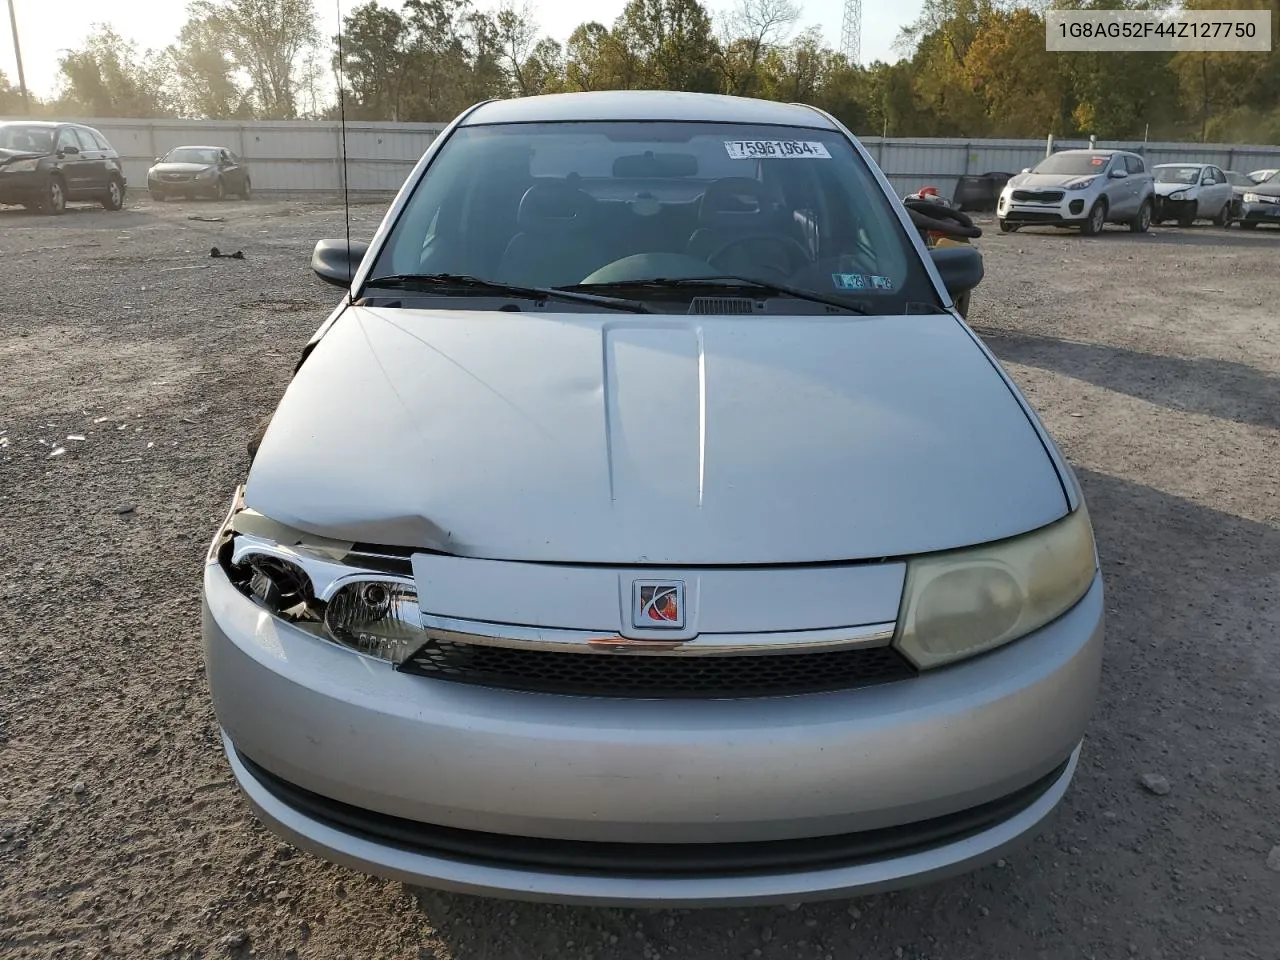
[210,511,429,664]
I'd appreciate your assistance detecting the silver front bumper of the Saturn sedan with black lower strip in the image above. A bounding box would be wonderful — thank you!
[204,566,1103,905]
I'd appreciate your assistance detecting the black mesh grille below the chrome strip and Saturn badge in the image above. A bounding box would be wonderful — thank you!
[399,640,915,699]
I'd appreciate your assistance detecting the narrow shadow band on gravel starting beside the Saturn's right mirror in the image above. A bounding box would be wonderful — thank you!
[974,325,1280,429]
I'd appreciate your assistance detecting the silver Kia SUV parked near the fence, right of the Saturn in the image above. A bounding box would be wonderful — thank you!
[996,150,1155,237]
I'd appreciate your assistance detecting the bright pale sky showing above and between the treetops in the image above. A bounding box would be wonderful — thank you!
[0,0,920,97]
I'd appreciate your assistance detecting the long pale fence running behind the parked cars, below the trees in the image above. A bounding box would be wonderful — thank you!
[13,118,1280,196]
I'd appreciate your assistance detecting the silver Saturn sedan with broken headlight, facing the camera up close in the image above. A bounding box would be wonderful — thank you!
[204,92,1103,905]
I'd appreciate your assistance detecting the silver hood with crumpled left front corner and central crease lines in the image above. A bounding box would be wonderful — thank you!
[244,307,1068,564]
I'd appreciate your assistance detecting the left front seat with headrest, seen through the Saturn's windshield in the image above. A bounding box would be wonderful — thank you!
[499,180,611,287]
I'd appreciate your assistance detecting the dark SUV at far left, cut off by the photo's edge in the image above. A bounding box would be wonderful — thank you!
[0,120,128,215]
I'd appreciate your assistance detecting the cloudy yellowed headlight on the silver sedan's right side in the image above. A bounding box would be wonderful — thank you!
[893,504,1097,669]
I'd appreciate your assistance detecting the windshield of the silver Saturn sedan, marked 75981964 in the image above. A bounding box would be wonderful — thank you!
[370,122,938,314]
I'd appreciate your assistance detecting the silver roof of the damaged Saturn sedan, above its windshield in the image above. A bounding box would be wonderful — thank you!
[462,90,836,129]
